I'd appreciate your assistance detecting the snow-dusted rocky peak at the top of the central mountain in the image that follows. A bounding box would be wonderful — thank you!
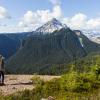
[36,18,67,33]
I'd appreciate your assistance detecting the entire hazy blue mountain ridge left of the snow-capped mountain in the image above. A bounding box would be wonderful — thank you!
[0,32,31,59]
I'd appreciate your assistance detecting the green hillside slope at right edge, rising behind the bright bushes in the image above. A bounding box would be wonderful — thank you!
[71,52,100,72]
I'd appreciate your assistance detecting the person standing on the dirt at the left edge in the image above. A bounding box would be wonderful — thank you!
[0,55,5,85]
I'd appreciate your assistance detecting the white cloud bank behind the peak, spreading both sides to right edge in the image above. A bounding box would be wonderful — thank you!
[18,5,100,30]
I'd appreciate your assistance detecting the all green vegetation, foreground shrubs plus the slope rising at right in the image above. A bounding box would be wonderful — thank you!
[1,53,100,100]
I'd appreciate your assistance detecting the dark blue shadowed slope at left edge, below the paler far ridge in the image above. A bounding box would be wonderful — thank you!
[0,34,20,59]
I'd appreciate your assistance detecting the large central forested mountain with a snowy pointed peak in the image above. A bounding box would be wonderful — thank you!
[6,18,100,74]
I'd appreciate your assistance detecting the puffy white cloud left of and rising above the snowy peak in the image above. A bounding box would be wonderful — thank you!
[18,5,62,27]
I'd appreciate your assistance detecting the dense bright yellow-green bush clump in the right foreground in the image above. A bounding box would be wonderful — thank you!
[61,71,100,92]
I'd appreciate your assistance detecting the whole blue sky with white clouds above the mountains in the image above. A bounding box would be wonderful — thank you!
[0,0,100,33]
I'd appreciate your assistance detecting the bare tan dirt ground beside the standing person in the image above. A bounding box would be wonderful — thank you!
[0,75,59,95]
